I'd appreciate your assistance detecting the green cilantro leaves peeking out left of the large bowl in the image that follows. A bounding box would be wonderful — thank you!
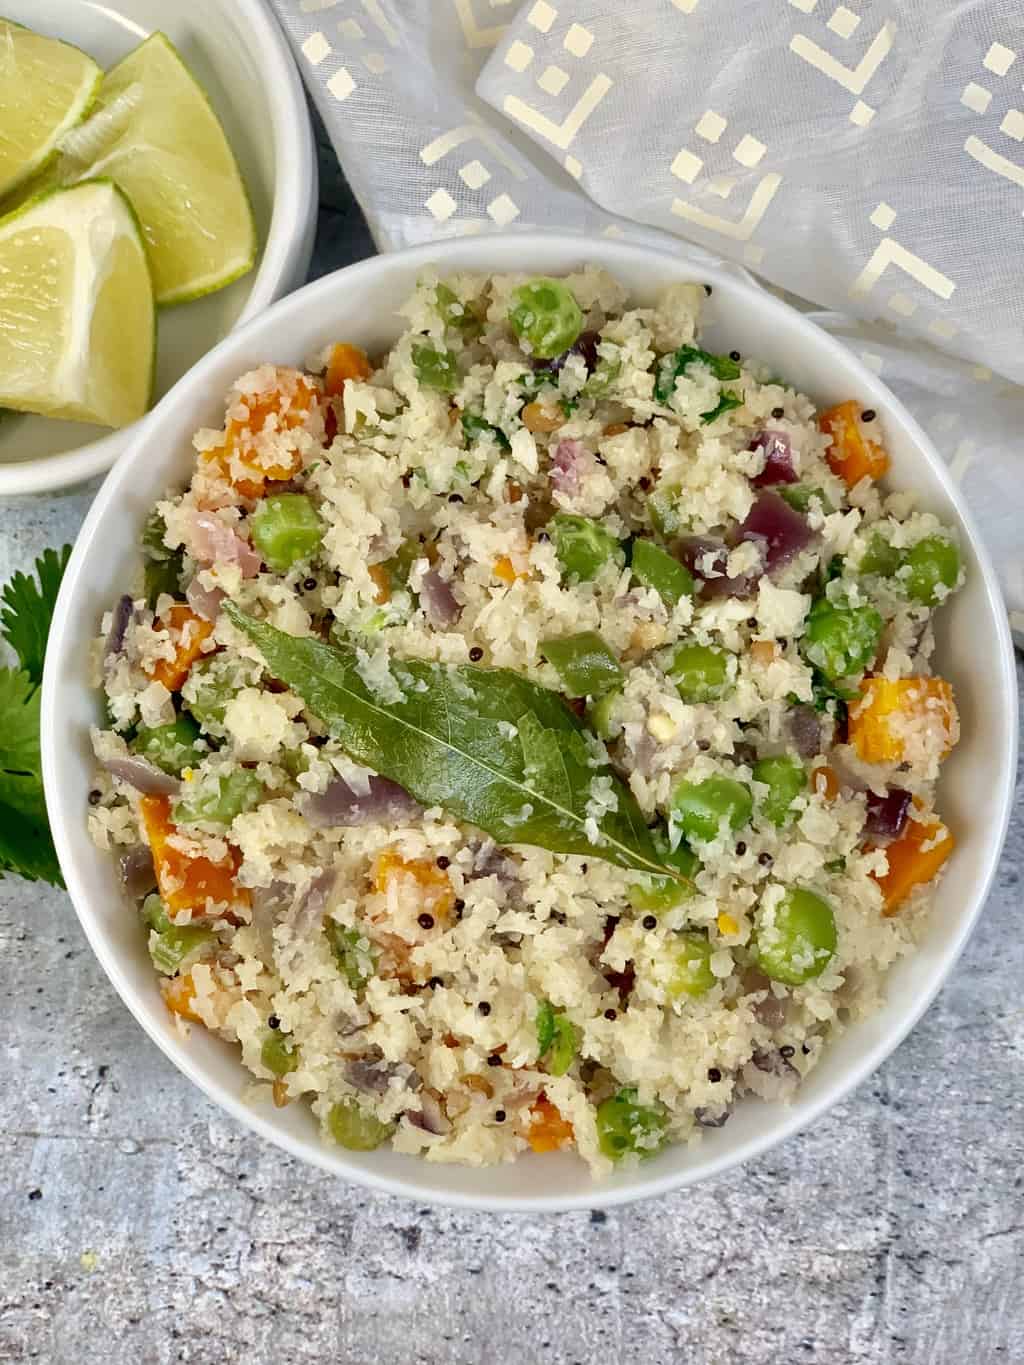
[0,545,71,886]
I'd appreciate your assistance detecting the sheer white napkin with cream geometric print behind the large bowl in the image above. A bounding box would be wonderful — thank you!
[272,0,1024,640]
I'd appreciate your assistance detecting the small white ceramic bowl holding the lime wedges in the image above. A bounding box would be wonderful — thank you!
[0,0,317,495]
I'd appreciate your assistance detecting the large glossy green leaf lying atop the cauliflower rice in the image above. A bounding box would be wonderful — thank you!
[224,602,680,876]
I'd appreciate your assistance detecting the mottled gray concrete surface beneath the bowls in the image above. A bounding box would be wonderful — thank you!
[0,120,1024,1365]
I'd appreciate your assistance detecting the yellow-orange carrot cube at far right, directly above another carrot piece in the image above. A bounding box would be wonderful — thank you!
[849,677,960,763]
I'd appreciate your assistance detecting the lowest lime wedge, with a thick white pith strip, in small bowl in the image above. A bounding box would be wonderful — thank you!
[0,180,156,427]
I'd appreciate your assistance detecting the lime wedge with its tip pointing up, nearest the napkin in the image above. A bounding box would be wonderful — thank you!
[55,33,257,306]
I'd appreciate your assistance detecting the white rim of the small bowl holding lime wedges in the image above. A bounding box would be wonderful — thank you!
[0,0,317,497]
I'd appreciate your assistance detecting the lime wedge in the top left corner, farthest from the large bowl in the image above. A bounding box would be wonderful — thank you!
[0,19,102,199]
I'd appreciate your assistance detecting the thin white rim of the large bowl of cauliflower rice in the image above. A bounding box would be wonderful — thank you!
[41,231,1019,1213]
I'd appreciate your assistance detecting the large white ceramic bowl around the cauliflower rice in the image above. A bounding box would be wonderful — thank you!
[42,233,1016,1211]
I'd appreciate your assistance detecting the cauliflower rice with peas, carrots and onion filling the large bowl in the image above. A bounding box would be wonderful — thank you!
[89,270,963,1175]
